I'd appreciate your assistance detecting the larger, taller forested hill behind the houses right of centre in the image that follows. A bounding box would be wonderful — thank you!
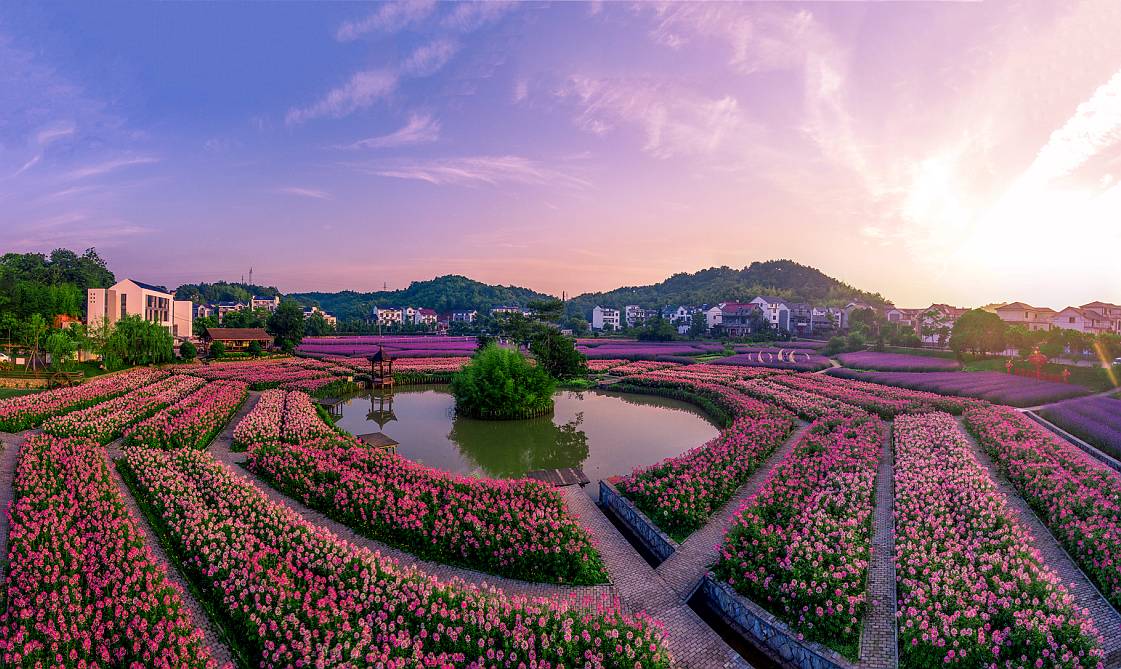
[568,260,884,317]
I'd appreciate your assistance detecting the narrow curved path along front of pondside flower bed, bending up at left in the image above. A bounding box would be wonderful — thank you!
[210,392,615,606]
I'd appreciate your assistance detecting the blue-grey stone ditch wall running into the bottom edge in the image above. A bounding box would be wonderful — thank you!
[700,574,856,669]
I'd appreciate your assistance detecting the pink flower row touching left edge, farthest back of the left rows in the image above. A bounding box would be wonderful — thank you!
[0,369,167,433]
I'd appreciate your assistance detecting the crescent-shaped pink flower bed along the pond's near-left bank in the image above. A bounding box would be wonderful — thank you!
[247,437,606,585]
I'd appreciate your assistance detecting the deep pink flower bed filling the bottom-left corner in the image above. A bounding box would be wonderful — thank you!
[0,435,216,669]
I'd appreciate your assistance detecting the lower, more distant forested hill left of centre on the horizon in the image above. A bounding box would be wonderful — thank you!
[288,275,550,319]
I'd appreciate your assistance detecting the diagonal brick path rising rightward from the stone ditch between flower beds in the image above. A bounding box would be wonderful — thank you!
[657,420,809,600]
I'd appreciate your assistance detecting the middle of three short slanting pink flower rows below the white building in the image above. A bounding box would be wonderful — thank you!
[43,374,205,444]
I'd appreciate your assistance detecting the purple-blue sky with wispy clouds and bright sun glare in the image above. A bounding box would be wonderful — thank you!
[0,0,1121,308]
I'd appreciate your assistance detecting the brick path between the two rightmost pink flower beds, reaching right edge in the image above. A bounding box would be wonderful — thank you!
[958,418,1121,669]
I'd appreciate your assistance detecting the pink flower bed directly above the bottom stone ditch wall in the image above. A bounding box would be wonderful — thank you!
[715,415,883,659]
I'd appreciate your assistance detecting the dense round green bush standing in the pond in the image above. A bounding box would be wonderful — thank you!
[452,344,556,419]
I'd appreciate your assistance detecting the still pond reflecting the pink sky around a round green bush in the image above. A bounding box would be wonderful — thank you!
[337,385,717,484]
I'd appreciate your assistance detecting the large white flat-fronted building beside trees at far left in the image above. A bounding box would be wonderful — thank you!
[85,279,195,340]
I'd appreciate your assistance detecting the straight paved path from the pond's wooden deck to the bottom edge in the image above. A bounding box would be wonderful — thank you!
[563,485,750,669]
